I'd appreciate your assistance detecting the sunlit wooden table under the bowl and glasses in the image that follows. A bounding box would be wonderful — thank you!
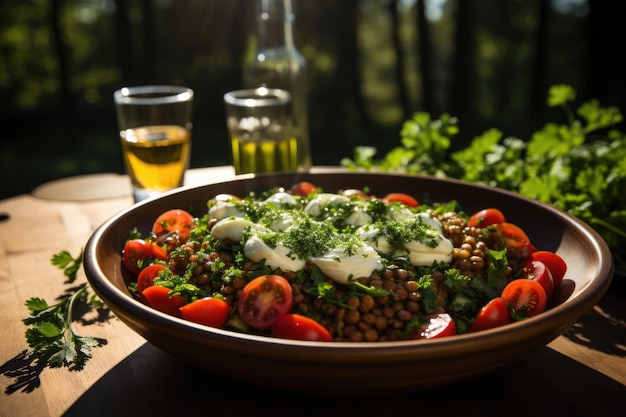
[0,167,626,417]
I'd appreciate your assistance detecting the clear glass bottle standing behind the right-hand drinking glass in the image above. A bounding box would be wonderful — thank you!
[243,0,312,171]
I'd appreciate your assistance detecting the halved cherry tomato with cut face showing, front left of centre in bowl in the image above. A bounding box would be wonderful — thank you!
[237,275,293,330]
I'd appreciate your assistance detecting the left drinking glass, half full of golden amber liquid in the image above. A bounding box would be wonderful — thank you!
[113,85,194,202]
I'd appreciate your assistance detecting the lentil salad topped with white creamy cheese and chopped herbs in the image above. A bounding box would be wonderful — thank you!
[124,184,564,342]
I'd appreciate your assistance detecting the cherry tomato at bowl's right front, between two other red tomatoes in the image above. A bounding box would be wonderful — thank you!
[501,278,548,319]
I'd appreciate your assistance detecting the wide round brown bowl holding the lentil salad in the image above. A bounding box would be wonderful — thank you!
[84,170,613,395]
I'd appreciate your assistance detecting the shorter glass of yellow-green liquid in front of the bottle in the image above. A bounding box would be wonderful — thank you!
[224,87,308,174]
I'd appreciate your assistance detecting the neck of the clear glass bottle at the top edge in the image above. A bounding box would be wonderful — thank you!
[257,0,295,50]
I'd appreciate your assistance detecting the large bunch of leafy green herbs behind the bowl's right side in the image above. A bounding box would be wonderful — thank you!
[341,85,626,271]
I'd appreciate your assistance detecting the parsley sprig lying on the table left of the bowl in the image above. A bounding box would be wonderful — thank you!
[23,250,105,370]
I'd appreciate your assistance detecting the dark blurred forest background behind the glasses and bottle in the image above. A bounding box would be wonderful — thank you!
[0,0,613,196]
